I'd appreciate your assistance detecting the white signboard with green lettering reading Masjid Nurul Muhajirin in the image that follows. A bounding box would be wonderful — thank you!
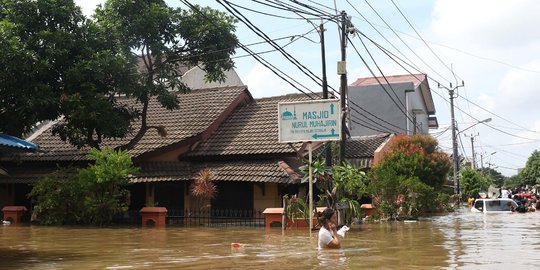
[278,99,341,143]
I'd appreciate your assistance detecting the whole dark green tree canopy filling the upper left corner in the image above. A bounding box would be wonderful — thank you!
[0,0,238,149]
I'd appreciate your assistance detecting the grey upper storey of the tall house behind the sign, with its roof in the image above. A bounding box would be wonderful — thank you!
[348,74,438,136]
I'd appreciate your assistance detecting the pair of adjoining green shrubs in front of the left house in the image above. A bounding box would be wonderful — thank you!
[30,148,137,226]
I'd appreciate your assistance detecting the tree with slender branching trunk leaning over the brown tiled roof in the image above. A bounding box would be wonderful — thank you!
[93,0,238,149]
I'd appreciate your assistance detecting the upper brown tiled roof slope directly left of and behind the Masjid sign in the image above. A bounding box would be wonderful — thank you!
[187,94,318,157]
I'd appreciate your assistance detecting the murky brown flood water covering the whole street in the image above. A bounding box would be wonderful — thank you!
[0,209,540,270]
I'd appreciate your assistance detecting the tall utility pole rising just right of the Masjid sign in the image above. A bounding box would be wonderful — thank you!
[338,11,350,164]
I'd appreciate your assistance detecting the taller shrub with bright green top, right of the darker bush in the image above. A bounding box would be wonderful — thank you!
[79,148,138,226]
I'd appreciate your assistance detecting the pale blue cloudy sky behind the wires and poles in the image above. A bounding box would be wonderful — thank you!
[75,0,540,176]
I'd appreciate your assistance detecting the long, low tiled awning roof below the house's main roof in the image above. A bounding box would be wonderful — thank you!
[131,160,299,183]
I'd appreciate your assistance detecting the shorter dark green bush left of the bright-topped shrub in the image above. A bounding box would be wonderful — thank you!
[28,167,84,225]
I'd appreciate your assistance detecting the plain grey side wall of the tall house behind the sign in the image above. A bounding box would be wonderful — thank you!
[349,83,428,136]
